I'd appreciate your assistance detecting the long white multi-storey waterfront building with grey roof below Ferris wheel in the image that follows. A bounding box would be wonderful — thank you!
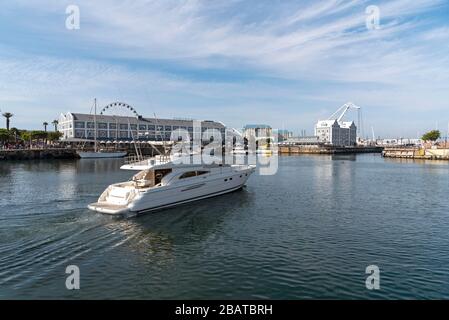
[58,112,226,141]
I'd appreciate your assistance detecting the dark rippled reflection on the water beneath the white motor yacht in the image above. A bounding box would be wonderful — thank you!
[98,188,255,264]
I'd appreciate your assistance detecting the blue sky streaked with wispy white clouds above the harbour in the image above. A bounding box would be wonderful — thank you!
[0,0,449,137]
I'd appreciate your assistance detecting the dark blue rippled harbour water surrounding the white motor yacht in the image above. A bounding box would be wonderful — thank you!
[0,155,449,299]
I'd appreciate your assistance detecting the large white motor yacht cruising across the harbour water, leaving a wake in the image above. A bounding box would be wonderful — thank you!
[88,162,255,215]
